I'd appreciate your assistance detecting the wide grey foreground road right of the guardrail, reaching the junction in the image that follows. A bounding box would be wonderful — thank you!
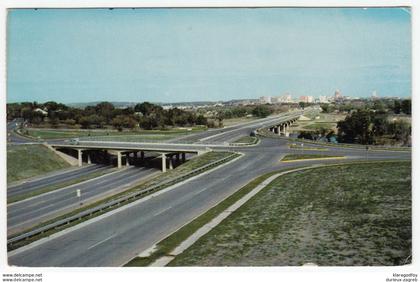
[9,135,411,266]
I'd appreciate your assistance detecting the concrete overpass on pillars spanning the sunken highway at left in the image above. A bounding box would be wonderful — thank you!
[48,141,211,172]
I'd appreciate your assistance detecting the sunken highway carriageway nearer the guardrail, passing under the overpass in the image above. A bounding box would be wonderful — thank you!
[7,167,158,234]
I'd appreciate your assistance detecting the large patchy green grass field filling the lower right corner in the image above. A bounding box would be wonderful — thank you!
[170,162,412,266]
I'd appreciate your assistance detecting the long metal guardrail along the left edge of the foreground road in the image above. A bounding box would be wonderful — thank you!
[7,154,238,246]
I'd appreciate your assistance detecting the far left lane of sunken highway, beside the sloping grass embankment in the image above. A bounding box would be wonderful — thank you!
[7,164,111,198]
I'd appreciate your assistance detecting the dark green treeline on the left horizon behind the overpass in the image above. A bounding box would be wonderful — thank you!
[7,102,208,130]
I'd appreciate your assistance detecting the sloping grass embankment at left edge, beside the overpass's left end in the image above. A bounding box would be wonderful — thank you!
[7,145,70,183]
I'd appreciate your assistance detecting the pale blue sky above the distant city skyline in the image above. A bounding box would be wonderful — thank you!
[7,8,411,103]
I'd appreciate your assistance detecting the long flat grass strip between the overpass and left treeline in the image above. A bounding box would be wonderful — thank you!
[23,127,204,142]
